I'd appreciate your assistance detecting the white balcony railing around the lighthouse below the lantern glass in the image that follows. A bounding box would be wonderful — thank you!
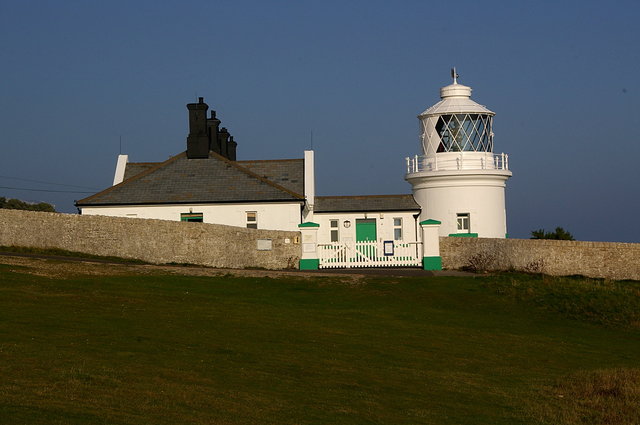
[405,152,509,174]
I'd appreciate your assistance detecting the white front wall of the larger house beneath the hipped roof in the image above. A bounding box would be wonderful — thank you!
[82,203,301,231]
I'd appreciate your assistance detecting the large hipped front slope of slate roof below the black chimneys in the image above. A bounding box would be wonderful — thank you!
[76,152,304,206]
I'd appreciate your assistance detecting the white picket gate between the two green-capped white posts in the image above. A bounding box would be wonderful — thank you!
[318,241,422,269]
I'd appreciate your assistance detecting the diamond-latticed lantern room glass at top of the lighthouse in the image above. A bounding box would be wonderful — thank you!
[436,114,493,152]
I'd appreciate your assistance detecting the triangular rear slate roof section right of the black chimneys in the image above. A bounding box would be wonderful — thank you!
[236,159,304,195]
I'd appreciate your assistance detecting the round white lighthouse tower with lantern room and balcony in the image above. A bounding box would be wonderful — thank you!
[405,68,511,238]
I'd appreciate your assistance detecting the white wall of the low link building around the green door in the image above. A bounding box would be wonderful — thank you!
[314,211,417,243]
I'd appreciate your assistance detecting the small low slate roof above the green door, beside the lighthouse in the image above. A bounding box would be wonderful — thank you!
[314,195,420,212]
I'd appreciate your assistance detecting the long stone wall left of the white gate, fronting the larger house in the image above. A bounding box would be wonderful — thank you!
[0,209,301,269]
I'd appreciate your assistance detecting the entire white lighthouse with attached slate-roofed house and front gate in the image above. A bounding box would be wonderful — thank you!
[76,71,511,268]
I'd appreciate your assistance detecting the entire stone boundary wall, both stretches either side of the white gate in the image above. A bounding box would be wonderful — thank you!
[0,209,640,280]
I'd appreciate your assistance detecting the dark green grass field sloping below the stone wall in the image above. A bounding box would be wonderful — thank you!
[0,258,640,424]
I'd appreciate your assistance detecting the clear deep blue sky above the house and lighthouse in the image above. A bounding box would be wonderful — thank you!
[0,0,640,242]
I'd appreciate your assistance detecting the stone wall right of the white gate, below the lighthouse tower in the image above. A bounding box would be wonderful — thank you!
[440,237,640,280]
